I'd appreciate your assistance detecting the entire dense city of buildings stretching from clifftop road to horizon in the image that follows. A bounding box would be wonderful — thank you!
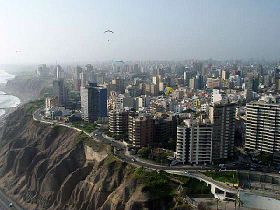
[40,60,280,164]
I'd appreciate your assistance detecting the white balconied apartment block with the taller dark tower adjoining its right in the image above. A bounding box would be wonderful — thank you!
[175,102,236,164]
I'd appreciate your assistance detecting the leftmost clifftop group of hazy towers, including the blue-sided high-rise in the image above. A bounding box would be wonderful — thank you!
[43,64,107,123]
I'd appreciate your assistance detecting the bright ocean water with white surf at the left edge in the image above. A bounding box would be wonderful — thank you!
[0,70,20,116]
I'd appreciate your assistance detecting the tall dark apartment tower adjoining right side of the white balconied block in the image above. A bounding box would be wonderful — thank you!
[209,102,236,160]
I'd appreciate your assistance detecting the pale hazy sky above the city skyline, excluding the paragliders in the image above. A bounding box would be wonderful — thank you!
[0,0,280,64]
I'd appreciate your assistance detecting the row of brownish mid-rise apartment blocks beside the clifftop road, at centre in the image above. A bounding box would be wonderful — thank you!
[109,110,179,148]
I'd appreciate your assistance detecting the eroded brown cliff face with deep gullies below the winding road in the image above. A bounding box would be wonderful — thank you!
[0,105,177,210]
